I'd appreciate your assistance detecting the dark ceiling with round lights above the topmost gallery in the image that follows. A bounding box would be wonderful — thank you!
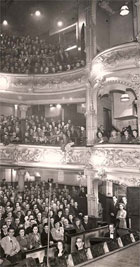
[1,0,89,36]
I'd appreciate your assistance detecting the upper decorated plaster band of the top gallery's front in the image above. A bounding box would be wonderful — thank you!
[0,68,88,94]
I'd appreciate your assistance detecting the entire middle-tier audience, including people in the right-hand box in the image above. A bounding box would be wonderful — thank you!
[0,115,140,147]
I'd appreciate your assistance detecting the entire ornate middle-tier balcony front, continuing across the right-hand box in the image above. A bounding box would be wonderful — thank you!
[0,144,140,186]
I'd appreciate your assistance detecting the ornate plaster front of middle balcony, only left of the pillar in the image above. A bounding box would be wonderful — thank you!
[0,145,90,168]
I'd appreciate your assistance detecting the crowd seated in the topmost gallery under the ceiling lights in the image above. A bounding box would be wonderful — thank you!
[0,34,85,74]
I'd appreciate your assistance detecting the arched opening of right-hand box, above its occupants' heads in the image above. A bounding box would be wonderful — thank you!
[97,85,138,135]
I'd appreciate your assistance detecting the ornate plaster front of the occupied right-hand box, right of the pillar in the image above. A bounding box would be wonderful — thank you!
[89,145,140,173]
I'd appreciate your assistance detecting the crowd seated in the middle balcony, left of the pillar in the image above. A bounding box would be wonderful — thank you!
[0,115,86,147]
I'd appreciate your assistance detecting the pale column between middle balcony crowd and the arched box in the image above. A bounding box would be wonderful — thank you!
[86,84,97,145]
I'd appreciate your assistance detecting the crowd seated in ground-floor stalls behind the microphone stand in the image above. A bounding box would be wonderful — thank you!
[0,180,93,263]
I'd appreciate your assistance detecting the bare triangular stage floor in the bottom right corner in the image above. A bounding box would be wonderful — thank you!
[85,243,140,267]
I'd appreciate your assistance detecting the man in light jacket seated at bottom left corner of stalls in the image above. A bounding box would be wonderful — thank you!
[1,227,20,263]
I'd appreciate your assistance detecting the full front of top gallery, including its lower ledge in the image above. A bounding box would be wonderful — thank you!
[0,67,88,104]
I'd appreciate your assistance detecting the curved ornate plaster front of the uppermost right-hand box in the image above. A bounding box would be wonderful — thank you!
[90,42,140,97]
